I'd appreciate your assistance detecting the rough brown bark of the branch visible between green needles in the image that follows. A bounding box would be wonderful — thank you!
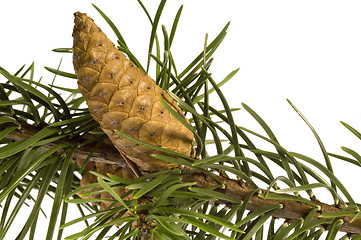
[0,121,361,236]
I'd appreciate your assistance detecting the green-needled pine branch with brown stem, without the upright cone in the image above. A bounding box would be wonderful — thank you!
[0,0,361,240]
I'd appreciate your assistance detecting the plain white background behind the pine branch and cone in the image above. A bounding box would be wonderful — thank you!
[0,0,361,239]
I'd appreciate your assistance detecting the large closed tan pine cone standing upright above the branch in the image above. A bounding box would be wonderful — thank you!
[73,12,194,171]
